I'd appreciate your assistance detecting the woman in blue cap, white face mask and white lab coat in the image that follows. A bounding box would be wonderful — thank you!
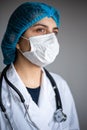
[0,2,79,130]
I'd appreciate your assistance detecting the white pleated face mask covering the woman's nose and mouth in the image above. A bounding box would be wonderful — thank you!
[22,33,59,67]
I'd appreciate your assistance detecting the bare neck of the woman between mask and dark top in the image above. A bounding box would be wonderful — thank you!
[14,50,42,88]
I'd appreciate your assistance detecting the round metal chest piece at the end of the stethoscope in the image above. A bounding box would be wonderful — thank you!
[54,109,67,123]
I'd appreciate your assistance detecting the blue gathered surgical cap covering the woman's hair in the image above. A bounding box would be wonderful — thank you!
[1,2,60,65]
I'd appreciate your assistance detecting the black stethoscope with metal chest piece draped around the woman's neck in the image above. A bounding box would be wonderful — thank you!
[0,65,67,130]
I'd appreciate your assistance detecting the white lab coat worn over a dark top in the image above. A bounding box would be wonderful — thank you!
[0,64,79,130]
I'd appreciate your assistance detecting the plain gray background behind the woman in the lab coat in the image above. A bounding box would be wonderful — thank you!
[0,0,87,130]
